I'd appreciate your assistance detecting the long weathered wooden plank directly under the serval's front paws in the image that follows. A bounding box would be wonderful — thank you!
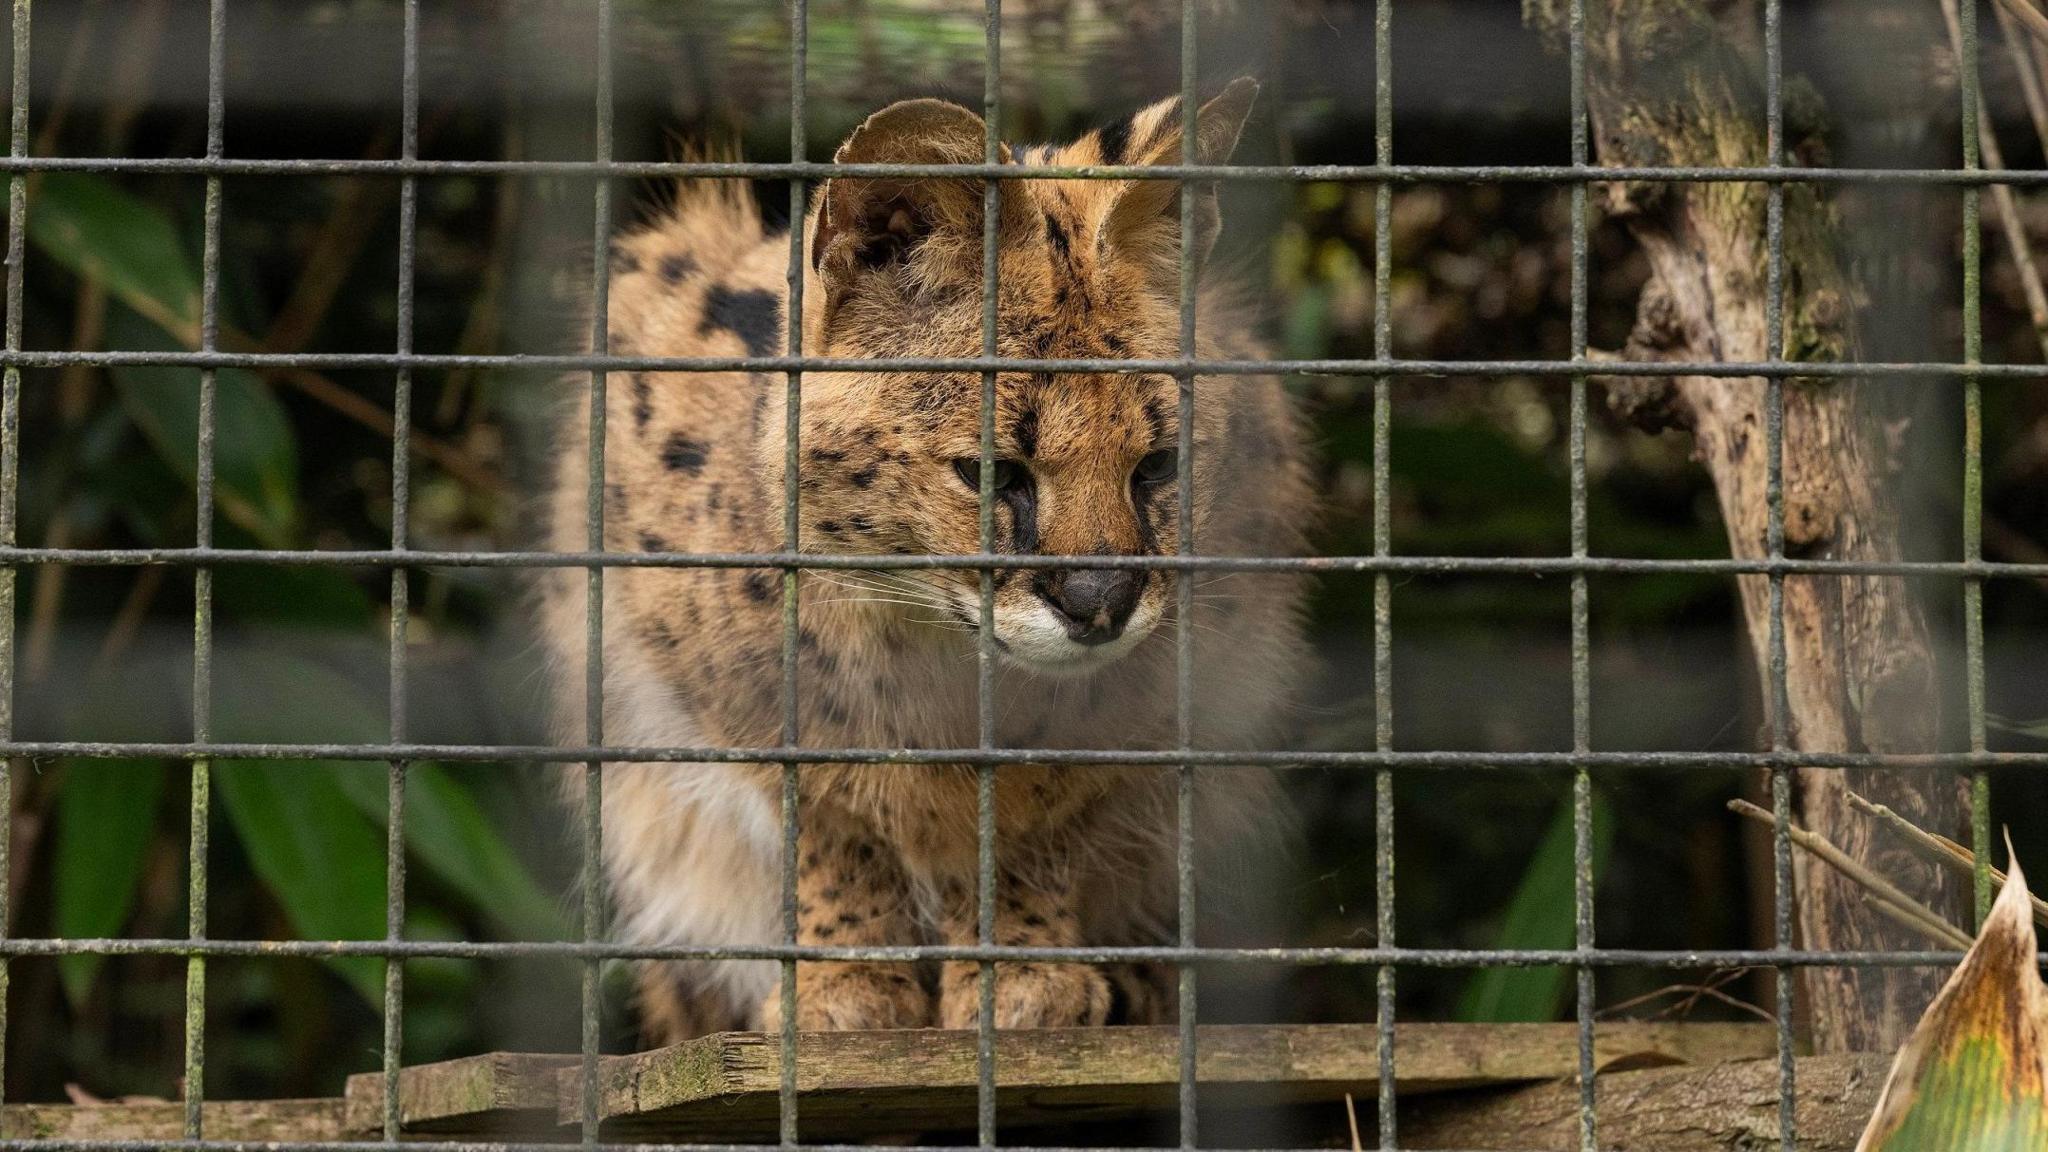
[557,1023,1776,1142]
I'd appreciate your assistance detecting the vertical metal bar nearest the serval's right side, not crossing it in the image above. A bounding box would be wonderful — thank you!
[1372,0,1397,1150]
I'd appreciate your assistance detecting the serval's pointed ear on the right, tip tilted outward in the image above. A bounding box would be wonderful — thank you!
[1098,76,1260,264]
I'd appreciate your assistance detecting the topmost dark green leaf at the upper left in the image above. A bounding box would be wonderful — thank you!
[29,172,199,338]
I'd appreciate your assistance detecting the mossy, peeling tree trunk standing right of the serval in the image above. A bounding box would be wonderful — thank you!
[1524,0,1964,1052]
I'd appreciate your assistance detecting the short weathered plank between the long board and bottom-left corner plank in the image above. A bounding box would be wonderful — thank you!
[344,1052,578,1136]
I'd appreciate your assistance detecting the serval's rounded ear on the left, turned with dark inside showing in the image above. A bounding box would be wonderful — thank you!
[811,100,1024,314]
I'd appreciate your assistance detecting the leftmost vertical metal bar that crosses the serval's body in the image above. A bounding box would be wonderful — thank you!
[580,0,612,1148]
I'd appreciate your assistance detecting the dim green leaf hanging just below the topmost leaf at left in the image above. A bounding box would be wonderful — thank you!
[106,310,299,547]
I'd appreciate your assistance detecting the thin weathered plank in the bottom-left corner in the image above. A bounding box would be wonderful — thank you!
[0,1099,350,1144]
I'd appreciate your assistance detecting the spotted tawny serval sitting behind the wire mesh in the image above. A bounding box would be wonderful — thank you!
[543,80,1311,1041]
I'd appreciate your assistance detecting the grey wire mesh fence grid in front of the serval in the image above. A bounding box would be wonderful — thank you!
[0,0,2048,1152]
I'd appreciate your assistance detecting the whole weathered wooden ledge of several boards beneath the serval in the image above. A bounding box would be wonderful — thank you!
[16,1023,1776,1142]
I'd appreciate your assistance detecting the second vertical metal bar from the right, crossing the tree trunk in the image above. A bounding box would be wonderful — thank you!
[1761,0,1798,1152]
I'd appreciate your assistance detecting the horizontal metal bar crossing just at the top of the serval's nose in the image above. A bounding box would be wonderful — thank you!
[0,547,2048,580]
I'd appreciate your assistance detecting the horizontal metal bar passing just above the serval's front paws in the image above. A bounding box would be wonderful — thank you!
[0,937,1998,968]
